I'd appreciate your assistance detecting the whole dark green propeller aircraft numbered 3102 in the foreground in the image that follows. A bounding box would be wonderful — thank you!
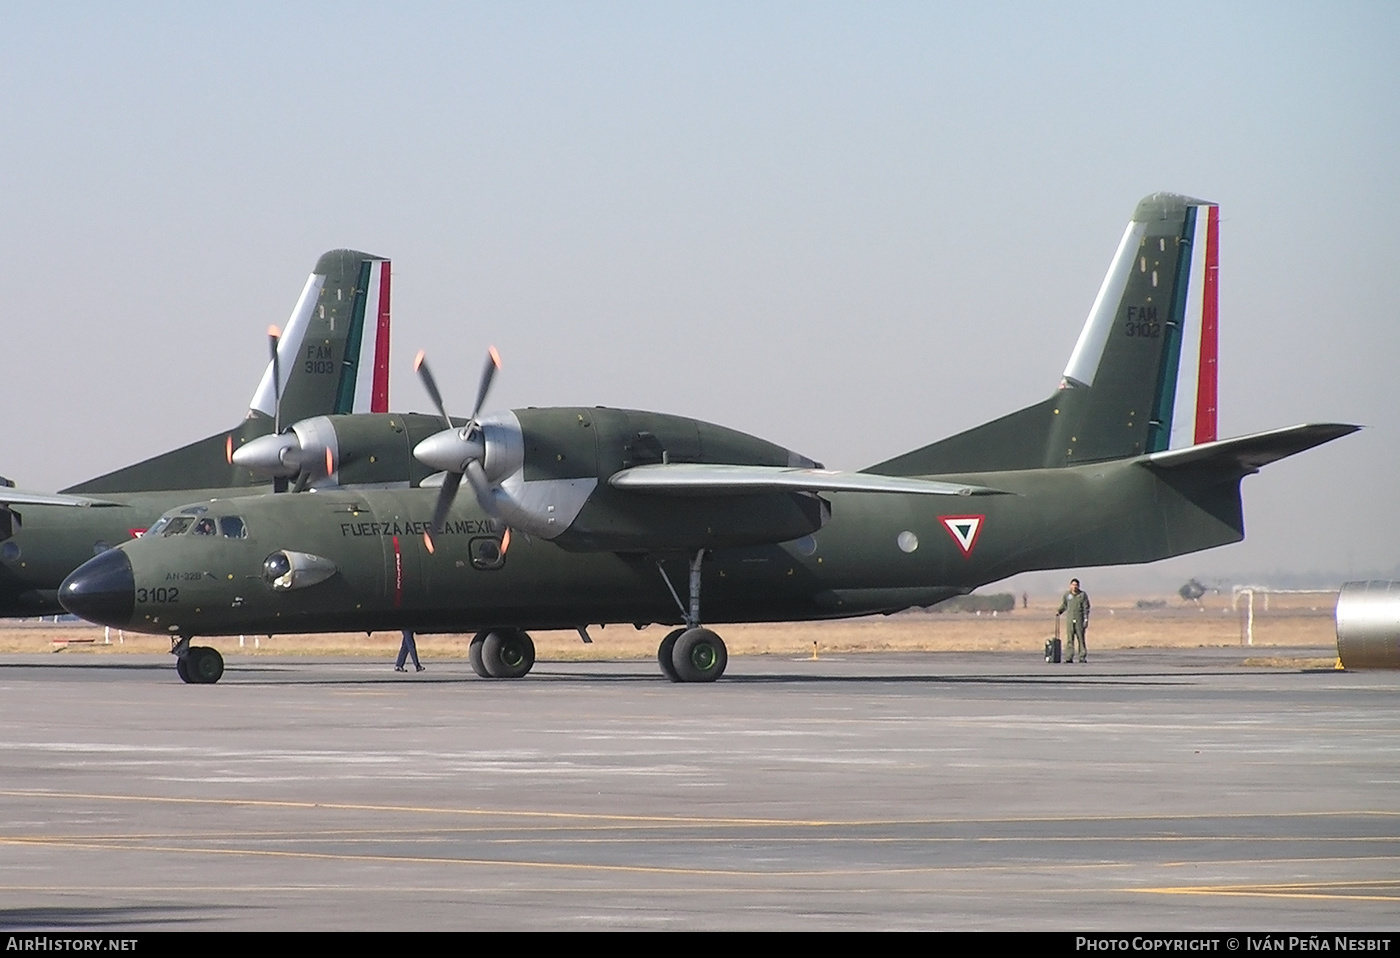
[60,193,1357,682]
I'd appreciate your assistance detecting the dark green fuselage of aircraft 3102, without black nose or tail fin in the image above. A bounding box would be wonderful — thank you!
[103,439,1243,636]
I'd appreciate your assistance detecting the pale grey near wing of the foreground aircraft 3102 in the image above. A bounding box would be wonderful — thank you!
[608,462,1007,496]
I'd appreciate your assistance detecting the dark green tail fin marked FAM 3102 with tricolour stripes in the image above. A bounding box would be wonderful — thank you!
[867,193,1219,476]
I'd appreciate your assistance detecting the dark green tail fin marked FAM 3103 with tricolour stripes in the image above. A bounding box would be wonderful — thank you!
[64,249,389,493]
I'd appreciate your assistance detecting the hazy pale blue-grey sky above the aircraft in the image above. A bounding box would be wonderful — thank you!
[0,1,1400,591]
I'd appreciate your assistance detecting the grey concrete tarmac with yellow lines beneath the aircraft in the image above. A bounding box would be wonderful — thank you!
[0,648,1400,933]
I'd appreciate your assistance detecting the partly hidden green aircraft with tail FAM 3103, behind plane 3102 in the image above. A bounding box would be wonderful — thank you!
[0,249,389,616]
